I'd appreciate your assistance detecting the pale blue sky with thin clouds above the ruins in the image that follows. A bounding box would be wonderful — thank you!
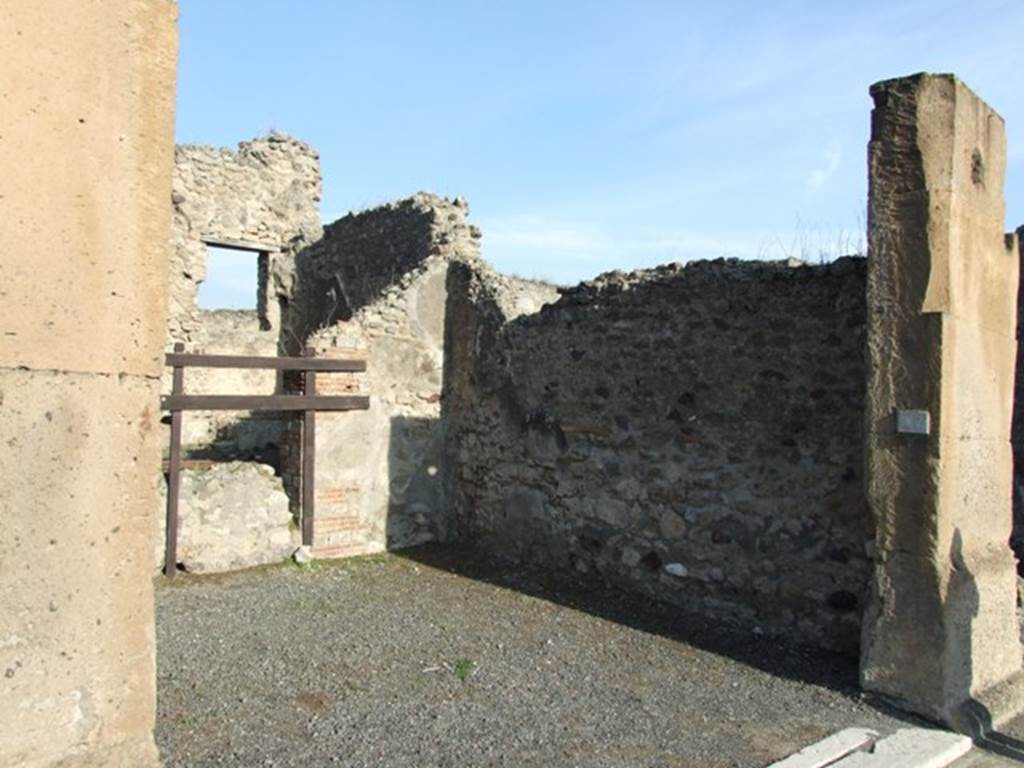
[177,0,1024,296]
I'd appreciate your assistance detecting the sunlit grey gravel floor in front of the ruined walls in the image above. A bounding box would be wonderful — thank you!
[157,548,918,768]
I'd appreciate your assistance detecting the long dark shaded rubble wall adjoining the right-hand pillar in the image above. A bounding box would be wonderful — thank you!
[443,258,872,649]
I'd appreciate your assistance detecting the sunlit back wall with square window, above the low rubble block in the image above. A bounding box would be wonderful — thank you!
[164,133,322,450]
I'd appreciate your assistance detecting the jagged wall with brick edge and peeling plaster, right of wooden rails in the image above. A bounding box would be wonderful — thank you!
[287,194,552,556]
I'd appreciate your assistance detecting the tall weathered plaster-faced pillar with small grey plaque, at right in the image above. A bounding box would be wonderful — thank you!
[861,75,1021,730]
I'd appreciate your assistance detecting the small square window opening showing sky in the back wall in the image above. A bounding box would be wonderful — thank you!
[196,245,270,331]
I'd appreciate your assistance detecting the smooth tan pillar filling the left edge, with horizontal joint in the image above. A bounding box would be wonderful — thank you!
[0,0,176,768]
